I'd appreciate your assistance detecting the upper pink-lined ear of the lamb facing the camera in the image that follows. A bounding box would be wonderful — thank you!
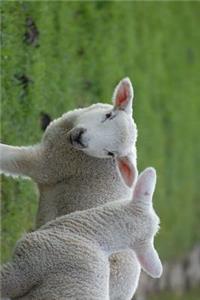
[113,77,134,114]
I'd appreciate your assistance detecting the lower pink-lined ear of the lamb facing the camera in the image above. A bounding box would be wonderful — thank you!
[116,156,137,187]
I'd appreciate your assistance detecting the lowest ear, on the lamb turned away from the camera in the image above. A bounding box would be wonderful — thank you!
[135,243,163,278]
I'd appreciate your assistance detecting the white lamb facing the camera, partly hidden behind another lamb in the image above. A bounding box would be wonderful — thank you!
[0,78,140,300]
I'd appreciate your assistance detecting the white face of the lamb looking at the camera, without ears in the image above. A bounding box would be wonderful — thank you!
[70,105,136,158]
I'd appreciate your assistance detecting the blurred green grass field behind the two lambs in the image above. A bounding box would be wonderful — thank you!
[1,1,200,298]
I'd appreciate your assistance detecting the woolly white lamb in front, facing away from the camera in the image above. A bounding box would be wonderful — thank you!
[1,168,162,300]
